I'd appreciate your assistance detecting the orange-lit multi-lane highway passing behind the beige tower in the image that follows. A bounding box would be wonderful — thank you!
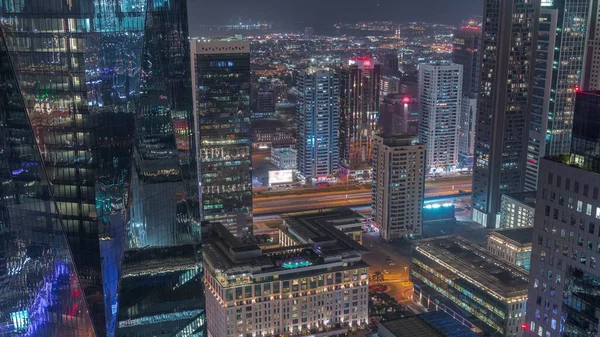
[254,176,471,215]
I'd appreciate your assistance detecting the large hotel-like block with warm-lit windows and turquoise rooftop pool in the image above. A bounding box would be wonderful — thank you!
[203,221,369,337]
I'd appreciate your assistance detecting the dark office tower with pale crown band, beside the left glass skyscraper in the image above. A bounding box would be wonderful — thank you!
[191,38,252,237]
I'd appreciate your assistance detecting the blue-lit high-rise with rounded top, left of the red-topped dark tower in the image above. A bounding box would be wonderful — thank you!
[296,67,340,178]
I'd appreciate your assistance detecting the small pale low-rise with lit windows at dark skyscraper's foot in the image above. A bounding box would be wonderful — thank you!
[498,191,536,228]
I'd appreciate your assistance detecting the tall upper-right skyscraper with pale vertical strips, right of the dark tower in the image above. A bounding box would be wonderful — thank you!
[525,0,598,191]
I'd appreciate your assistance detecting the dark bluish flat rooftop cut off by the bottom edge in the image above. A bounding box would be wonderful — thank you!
[381,311,478,337]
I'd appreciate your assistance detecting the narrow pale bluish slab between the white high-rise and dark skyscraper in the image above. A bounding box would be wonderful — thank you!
[458,94,477,169]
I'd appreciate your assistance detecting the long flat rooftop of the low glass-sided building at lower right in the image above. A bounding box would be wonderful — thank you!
[413,235,529,300]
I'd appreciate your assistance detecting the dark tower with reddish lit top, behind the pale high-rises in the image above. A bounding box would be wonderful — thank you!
[452,25,481,95]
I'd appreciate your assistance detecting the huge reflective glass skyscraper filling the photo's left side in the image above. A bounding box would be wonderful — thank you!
[0,0,204,336]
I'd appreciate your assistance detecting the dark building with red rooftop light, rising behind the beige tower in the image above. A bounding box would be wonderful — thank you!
[378,94,419,135]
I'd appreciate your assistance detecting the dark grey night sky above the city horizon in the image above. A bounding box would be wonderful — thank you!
[188,0,483,36]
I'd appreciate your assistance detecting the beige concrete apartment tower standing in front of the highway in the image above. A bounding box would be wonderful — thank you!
[372,134,425,240]
